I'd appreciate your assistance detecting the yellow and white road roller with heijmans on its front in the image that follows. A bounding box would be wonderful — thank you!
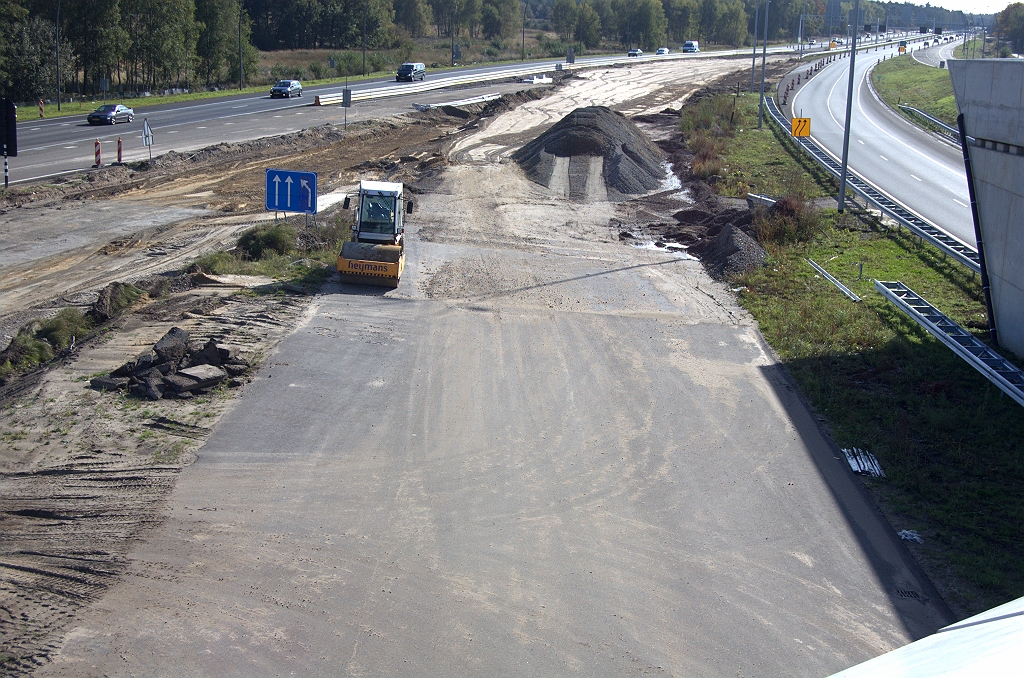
[338,181,413,288]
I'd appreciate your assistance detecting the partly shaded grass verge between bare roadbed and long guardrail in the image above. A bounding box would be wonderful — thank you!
[692,93,1024,617]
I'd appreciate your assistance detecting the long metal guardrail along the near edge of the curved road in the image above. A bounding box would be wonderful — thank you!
[765,96,981,273]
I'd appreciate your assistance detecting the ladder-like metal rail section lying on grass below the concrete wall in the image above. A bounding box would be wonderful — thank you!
[874,281,1024,406]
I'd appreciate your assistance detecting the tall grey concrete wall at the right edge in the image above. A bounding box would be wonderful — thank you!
[947,58,1024,356]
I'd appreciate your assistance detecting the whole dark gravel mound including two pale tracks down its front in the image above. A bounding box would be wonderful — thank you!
[512,107,666,200]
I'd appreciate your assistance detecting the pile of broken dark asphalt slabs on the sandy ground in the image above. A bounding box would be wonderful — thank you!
[89,327,250,400]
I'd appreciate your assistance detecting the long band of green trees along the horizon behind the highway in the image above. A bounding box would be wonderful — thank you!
[0,0,983,100]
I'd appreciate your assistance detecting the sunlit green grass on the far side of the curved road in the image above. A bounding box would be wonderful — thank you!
[871,54,957,126]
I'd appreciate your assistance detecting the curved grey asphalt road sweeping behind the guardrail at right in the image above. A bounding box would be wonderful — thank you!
[792,41,976,246]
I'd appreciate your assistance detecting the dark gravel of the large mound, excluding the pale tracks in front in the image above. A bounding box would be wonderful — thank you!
[512,105,666,200]
